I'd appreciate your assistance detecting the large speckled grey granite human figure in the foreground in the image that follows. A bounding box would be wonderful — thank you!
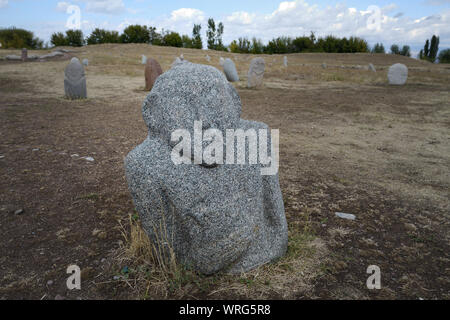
[125,62,288,274]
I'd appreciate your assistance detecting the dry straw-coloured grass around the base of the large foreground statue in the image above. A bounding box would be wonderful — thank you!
[115,205,327,299]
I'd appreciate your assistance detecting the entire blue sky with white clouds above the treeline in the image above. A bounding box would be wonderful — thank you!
[0,0,450,53]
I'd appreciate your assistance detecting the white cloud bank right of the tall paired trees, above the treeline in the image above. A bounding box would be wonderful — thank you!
[222,0,450,47]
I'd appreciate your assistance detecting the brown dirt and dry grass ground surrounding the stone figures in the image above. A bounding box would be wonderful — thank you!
[0,45,450,299]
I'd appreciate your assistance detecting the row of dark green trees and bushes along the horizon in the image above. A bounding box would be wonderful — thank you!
[0,25,450,63]
